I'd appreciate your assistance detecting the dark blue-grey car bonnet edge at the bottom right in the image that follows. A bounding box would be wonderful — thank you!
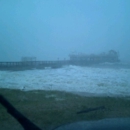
[55,118,130,130]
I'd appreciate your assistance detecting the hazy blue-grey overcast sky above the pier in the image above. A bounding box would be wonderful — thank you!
[0,0,130,61]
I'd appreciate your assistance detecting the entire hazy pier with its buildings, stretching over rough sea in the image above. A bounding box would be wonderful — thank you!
[0,50,120,70]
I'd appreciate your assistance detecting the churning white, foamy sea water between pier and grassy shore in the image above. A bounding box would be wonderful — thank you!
[0,63,130,96]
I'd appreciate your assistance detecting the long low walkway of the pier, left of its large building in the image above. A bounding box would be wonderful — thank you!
[0,60,69,70]
